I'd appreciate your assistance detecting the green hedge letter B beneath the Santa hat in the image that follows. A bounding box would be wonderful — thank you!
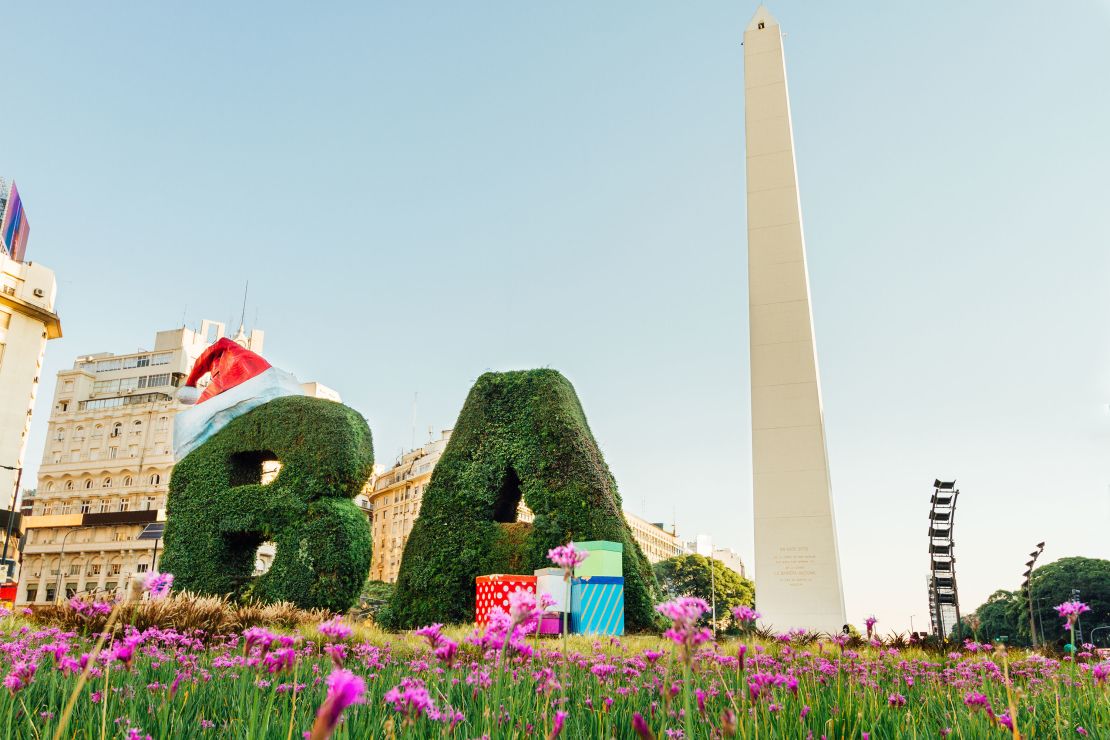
[162,396,374,611]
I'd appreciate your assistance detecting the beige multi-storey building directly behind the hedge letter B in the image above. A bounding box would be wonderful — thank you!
[17,321,263,604]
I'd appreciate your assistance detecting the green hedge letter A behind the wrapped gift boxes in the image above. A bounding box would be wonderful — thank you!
[391,369,657,630]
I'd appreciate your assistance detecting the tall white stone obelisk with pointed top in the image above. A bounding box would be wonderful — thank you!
[744,6,846,632]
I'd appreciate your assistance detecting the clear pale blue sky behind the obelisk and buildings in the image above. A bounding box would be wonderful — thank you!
[0,0,1110,629]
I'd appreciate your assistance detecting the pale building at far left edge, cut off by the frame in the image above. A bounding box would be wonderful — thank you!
[0,255,62,580]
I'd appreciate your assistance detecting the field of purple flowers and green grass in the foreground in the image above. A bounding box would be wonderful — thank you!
[0,596,1110,739]
